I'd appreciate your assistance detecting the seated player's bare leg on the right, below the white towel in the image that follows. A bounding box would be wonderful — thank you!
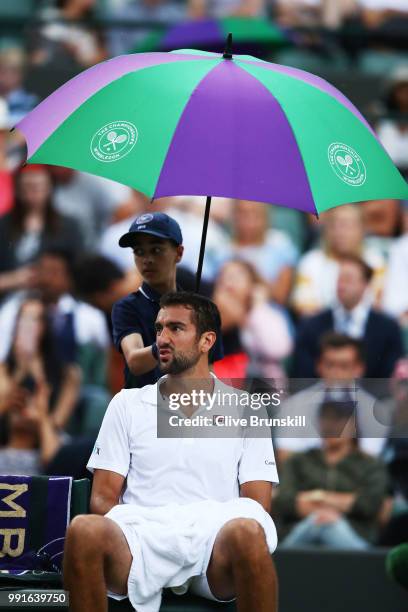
[207,518,278,612]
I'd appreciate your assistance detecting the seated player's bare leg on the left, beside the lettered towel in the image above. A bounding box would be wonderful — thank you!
[64,514,132,612]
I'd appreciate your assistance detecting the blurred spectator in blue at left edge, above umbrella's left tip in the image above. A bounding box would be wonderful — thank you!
[0,47,39,127]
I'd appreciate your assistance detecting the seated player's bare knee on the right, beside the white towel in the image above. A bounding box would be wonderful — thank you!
[226,518,267,561]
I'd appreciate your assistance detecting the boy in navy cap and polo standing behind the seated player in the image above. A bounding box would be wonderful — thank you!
[112,212,222,388]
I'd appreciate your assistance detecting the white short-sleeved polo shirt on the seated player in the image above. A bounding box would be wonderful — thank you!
[87,379,279,507]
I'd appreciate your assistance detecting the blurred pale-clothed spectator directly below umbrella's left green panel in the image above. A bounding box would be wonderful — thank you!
[50,166,132,250]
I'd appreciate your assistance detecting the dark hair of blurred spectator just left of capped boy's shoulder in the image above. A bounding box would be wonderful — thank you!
[74,255,124,296]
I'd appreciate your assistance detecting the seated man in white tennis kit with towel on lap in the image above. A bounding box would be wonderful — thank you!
[64,292,278,612]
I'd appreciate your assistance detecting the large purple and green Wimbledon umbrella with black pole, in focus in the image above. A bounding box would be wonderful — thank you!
[17,40,408,290]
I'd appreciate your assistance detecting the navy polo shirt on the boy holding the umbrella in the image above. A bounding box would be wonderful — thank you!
[112,282,224,389]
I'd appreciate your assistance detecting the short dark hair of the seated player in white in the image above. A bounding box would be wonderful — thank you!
[160,291,221,336]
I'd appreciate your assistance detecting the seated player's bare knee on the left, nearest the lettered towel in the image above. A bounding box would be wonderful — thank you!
[66,514,107,558]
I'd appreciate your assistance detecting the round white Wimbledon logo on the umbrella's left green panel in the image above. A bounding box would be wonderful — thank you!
[91,121,138,162]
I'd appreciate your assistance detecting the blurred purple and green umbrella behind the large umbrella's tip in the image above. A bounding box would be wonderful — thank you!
[131,16,292,53]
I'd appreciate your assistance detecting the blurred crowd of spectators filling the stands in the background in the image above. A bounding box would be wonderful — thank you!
[0,0,408,548]
